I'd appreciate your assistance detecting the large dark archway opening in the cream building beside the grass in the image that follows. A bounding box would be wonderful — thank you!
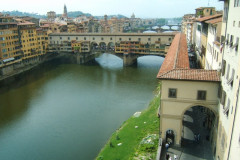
[181,105,218,159]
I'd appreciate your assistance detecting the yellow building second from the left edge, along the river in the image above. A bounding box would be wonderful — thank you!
[18,22,39,59]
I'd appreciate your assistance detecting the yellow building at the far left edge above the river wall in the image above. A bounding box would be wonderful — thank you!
[0,16,22,66]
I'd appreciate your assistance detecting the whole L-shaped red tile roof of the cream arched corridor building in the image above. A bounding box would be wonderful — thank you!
[157,33,220,82]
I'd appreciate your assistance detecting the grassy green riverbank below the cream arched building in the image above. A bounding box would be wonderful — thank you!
[96,87,160,160]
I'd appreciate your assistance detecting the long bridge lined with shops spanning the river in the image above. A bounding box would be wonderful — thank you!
[48,32,176,66]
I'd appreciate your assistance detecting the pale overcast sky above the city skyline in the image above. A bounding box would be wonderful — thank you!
[0,0,223,18]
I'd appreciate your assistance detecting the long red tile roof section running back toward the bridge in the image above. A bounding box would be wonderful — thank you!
[158,33,190,76]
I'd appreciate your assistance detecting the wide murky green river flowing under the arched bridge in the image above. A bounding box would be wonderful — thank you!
[0,54,164,160]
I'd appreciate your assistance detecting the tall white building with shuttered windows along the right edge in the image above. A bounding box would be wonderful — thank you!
[216,0,240,160]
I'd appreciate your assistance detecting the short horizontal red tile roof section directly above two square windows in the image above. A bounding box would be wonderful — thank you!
[157,69,220,82]
